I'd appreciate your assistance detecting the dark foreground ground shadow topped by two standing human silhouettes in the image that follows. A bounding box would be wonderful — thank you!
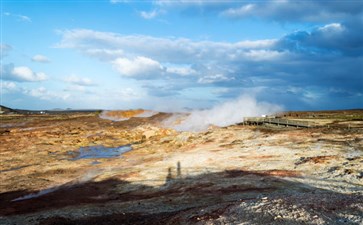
[0,162,363,225]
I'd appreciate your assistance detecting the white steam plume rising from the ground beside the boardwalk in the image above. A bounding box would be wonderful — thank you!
[168,95,282,131]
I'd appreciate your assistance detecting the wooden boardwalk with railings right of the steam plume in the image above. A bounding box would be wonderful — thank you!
[243,117,312,128]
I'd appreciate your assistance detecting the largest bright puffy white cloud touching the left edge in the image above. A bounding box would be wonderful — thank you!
[1,64,48,82]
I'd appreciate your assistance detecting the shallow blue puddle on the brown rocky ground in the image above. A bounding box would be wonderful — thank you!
[69,145,132,160]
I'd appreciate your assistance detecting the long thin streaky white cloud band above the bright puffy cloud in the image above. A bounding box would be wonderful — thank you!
[57,30,277,64]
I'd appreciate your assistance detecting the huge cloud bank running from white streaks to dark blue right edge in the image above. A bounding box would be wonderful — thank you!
[57,20,363,109]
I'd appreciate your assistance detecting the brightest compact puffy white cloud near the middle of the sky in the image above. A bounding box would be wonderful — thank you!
[112,56,164,78]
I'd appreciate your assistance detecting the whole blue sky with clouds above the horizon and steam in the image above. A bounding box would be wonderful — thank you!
[0,0,363,111]
